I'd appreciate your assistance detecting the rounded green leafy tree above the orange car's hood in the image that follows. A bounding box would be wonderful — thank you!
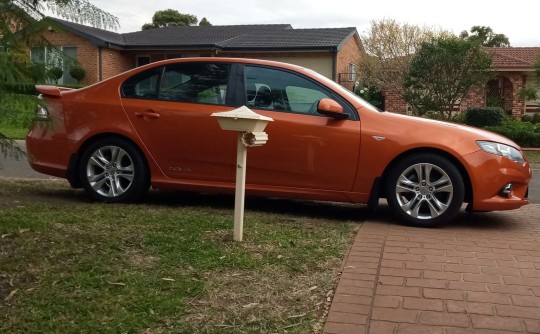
[404,37,492,119]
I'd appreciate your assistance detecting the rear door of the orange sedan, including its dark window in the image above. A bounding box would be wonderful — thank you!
[121,62,236,182]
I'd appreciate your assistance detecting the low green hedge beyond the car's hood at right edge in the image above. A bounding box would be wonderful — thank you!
[486,120,540,147]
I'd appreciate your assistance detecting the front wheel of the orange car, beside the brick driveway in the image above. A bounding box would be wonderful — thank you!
[386,153,465,227]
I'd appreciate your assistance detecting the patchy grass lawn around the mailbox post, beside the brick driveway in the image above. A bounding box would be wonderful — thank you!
[0,179,366,333]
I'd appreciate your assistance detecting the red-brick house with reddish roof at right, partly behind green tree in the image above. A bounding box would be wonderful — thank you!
[385,47,540,117]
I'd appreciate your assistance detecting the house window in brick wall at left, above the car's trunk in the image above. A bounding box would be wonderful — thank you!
[30,46,77,85]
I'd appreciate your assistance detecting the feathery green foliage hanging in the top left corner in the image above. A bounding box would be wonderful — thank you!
[0,0,118,162]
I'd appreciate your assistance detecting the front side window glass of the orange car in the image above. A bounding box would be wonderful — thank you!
[244,66,331,114]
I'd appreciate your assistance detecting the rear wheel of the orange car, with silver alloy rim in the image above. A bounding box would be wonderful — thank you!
[79,138,150,203]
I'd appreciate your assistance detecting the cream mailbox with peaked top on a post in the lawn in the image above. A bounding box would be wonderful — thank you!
[212,106,273,241]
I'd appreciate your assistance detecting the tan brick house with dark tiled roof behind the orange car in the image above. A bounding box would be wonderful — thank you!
[27,18,362,89]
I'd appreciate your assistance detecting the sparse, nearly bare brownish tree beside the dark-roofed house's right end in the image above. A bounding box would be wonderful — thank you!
[358,19,450,98]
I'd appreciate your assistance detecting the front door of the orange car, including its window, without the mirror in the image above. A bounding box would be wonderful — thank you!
[244,65,360,191]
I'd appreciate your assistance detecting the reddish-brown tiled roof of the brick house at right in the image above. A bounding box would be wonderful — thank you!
[485,47,540,69]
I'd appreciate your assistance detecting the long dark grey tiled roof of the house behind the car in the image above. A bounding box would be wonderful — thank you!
[44,18,357,51]
